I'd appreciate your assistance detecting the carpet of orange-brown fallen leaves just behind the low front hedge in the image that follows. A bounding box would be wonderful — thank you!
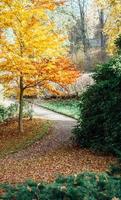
[0,148,114,183]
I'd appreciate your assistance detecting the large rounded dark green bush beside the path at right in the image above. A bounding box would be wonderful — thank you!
[74,55,121,155]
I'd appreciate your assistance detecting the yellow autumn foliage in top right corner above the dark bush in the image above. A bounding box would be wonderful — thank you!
[96,0,121,54]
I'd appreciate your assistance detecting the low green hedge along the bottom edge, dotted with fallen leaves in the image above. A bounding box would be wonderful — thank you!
[0,173,121,200]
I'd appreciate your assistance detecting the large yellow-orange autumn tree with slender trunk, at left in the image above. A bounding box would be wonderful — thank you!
[0,0,79,132]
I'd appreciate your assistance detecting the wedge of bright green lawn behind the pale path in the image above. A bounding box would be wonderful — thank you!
[41,99,80,119]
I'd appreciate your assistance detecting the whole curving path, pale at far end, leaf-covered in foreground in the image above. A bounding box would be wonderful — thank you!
[0,105,115,183]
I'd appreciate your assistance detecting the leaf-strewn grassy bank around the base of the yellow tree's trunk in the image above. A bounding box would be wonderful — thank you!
[0,119,50,157]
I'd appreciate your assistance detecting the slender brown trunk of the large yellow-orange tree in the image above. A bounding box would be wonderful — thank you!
[18,77,24,132]
